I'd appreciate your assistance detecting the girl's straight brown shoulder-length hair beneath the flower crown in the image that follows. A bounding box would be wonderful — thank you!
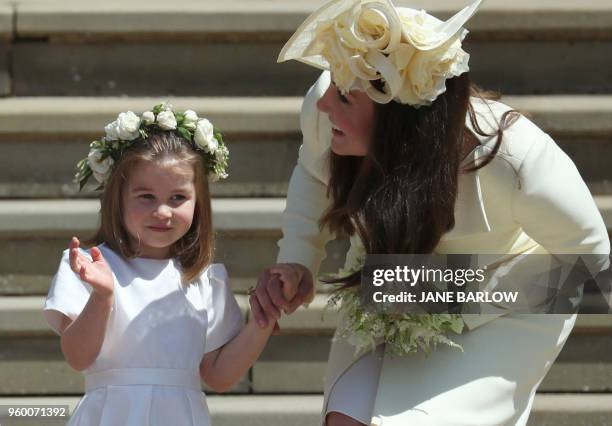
[87,132,214,283]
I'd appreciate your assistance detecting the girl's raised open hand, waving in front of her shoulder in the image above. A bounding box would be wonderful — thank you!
[69,237,115,297]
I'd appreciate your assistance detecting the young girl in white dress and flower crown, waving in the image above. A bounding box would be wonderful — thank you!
[44,105,291,426]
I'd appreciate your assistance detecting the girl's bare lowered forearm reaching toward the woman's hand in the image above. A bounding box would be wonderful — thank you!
[200,320,276,392]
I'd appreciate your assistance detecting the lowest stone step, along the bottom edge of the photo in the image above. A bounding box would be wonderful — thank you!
[0,394,612,426]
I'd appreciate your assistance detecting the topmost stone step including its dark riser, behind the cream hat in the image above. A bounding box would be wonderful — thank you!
[4,0,612,96]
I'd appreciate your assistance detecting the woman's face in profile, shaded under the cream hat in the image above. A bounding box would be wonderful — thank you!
[317,83,375,156]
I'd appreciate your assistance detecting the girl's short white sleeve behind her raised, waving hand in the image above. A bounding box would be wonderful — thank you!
[43,249,92,334]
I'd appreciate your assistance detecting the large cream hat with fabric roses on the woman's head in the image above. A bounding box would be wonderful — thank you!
[278,0,482,107]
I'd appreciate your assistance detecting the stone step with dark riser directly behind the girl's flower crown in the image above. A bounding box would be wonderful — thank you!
[0,95,612,198]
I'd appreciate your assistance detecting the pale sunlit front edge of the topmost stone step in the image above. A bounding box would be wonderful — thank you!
[13,0,612,37]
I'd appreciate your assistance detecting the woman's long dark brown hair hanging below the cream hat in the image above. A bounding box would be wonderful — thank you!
[319,73,518,286]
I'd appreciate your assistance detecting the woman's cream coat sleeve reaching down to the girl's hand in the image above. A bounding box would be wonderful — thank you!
[278,72,332,292]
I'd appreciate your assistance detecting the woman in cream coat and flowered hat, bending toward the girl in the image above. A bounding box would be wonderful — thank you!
[251,0,610,426]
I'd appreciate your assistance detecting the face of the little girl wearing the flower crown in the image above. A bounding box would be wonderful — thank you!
[123,162,196,259]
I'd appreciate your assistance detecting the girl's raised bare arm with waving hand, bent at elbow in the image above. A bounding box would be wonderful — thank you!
[60,238,114,371]
